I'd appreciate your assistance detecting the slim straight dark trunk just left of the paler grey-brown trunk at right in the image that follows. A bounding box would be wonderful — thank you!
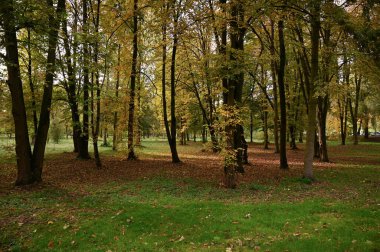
[278,20,289,169]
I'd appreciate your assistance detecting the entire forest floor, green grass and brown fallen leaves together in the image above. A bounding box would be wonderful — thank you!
[0,141,380,251]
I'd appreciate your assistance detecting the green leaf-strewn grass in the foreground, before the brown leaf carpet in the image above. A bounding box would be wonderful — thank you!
[0,175,380,251]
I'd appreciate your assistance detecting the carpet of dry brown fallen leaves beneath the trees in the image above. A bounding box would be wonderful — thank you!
[0,144,378,194]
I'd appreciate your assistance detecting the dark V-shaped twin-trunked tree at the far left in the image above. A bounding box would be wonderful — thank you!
[0,0,65,185]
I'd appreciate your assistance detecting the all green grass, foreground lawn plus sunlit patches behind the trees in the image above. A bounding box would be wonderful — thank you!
[0,137,380,251]
